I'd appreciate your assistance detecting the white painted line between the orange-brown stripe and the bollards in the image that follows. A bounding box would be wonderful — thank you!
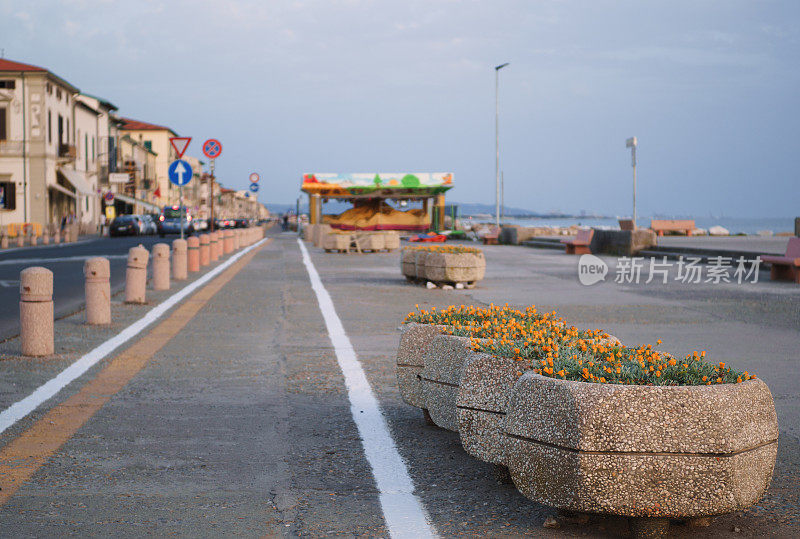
[0,239,267,433]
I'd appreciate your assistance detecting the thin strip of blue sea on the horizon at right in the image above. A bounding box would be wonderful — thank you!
[462,215,794,235]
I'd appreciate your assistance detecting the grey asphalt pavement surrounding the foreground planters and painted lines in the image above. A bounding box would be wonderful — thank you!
[0,233,800,538]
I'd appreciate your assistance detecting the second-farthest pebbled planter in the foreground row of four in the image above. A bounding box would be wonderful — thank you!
[420,335,472,432]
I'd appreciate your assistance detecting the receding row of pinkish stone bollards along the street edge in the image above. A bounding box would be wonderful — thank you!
[19,227,264,356]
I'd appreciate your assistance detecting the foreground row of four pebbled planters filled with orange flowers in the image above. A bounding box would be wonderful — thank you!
[398,305,778,531]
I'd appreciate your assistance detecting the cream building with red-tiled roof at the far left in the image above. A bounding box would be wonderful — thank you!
[0,59,97,230]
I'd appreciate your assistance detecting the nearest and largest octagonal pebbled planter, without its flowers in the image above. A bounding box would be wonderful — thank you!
[503,372,778,522]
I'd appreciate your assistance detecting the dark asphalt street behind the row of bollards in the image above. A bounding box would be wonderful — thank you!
[0,236,166,340]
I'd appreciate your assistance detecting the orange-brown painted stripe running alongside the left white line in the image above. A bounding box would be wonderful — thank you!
[0,236,269,506]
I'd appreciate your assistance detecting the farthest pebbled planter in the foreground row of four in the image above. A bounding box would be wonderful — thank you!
[395,324,445,409]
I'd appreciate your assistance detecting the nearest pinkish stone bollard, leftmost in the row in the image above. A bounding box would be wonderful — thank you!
[19,267,54,356]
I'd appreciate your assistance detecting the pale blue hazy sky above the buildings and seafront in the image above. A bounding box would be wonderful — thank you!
[0,0,800,217]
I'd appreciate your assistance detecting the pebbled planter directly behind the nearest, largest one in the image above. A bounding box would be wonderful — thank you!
[456,352,523,464]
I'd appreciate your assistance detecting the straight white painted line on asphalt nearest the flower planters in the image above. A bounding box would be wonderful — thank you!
[297,238,436,538]
